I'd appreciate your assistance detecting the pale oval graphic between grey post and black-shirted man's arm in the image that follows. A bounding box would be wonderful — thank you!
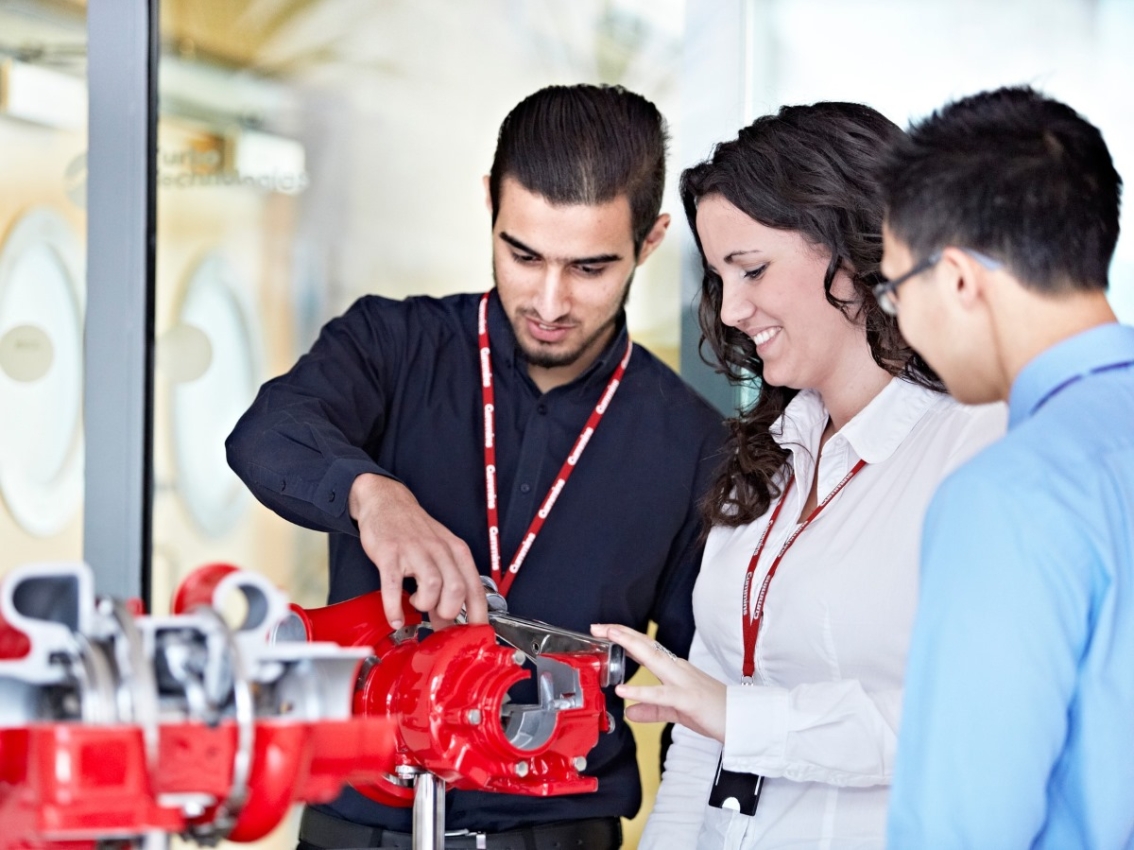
[168,252,261,537]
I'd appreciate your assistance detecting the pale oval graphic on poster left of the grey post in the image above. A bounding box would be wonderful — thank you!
[0,207,84,537]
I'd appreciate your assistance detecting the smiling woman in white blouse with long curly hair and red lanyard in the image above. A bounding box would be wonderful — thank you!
[594,103,1006,850]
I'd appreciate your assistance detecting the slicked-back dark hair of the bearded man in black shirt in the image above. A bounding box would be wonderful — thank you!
[489,85,667,253]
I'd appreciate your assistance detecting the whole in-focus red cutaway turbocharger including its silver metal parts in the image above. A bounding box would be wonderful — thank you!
[275,573,624,806]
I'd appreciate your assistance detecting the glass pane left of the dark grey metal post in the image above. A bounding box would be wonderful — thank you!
[0,0,87,573]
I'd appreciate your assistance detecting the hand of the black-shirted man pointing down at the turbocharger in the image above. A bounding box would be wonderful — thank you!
[349,473,488,629]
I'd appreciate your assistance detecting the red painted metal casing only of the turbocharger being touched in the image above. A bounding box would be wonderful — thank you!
[303,592,608,806]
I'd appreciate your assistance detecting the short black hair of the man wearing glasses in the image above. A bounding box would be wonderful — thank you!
[881,86,1123,292]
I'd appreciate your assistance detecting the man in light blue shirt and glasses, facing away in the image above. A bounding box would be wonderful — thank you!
[878,87,1134,850]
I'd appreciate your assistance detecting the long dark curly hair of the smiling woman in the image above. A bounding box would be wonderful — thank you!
[680,103,943,526]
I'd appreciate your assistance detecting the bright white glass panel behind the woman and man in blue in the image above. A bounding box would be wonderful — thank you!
[745,0,1134,322]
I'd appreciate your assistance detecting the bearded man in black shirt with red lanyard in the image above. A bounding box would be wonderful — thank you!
[228,86,723,849]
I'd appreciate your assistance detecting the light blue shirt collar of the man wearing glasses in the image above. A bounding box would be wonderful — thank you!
[1008,322,1134,428]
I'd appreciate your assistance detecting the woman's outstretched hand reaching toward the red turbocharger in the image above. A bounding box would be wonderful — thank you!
[591,623,726,743]
